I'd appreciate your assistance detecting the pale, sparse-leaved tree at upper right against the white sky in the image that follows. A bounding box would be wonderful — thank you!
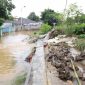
[65,3,82,25]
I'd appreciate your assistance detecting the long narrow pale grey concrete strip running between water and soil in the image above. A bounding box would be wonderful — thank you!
[31,40,47,85]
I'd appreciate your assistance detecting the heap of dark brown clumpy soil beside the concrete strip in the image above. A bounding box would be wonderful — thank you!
[46,42,78,80]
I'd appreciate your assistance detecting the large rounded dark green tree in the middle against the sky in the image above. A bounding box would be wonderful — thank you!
[41,9,62,26]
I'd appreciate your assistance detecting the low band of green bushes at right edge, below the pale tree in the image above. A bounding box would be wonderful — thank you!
[57,24,85,36]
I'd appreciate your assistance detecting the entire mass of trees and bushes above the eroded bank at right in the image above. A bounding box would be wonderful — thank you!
[40,3,85,51]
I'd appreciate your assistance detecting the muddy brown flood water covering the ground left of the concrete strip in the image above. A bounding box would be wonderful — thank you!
[0,33,32,85]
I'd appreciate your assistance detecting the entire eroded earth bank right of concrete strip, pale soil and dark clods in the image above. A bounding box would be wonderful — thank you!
[46,35,85,85]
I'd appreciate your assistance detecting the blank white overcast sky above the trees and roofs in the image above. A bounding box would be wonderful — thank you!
[12,0,85,17]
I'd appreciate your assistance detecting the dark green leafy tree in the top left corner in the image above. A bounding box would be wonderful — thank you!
[0,0,15,25]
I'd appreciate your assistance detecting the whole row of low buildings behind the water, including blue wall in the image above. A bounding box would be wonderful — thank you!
[0,18,42,35]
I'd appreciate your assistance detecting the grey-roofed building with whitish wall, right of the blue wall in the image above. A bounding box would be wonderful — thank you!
[13,18,42,30]
